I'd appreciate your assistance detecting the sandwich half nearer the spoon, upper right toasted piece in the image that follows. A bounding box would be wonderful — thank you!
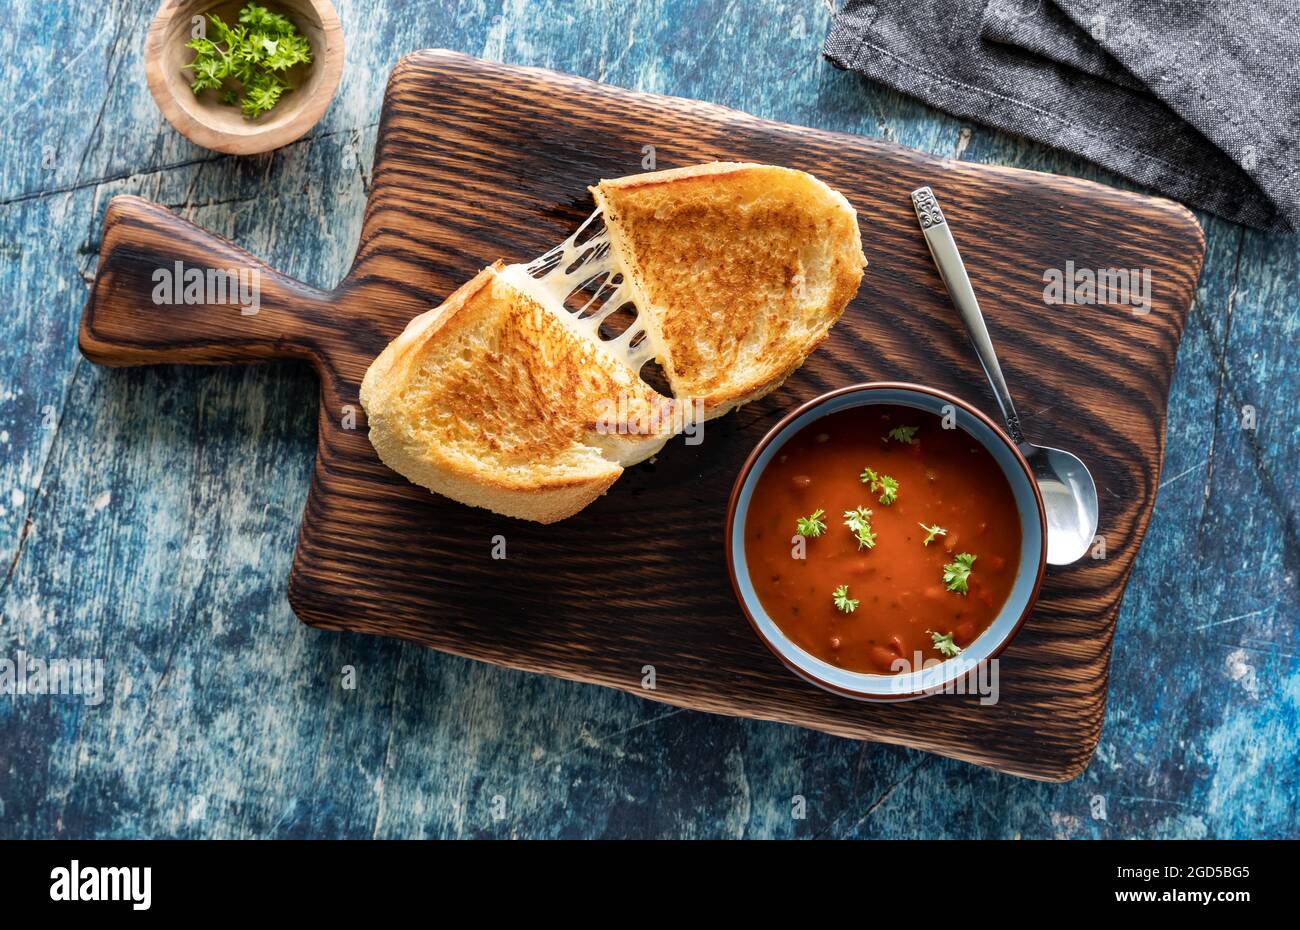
[590,163,866,418]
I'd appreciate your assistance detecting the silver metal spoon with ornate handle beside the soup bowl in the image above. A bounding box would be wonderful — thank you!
[911,187,1097,565]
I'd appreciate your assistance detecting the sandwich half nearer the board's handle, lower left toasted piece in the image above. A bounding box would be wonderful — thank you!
[361,261,672,523]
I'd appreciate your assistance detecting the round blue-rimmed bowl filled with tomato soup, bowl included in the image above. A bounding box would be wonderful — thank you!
[727,382,1047,700]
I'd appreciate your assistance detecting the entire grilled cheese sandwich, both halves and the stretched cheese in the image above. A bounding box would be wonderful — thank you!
[361,163,866,523]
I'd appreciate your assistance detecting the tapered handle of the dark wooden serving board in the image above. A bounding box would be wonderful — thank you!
[78,195,333,368]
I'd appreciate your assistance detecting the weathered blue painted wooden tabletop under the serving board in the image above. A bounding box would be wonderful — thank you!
[0,0,1300,838]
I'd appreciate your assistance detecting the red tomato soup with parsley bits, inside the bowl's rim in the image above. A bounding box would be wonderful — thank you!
[745,405,1021,675]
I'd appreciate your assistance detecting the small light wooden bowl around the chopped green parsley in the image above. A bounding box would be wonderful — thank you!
[144,0,343,155]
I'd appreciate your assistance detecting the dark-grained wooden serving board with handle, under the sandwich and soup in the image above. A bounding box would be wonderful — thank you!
[81,51,1204,779]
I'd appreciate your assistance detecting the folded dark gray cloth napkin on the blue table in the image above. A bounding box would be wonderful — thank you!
[823,0,1300,230]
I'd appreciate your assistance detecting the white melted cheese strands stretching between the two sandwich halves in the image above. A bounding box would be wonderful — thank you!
[501,209,659,373]
